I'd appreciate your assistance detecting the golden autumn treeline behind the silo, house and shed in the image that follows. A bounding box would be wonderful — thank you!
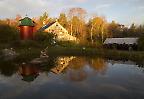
[0,8,144,49]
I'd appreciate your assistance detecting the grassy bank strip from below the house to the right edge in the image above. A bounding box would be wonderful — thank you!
[47,48,144,61]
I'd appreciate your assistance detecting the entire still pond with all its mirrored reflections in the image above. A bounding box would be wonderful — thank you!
[0,56,144,99]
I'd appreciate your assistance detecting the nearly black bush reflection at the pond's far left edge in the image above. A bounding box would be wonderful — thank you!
[0,61,18,76]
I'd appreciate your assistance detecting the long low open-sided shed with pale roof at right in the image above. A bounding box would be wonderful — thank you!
[104,38,138,50]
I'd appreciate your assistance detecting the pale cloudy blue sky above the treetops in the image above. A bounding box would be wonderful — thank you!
[0,0,144,25]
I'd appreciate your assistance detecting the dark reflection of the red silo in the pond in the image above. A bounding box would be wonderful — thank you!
[19,64,39,82]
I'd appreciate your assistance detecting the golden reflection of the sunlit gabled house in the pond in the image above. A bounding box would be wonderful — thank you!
[51,56,75,74]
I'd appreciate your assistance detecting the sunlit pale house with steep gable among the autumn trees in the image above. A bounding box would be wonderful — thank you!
[39,21,76,41]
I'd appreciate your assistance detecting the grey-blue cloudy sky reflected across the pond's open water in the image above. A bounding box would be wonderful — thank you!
[0,60,144,99]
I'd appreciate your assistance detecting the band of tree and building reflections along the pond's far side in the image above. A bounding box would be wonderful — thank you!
[0,56,144,82]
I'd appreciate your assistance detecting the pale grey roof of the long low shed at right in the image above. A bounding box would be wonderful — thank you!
[104,38,138,44]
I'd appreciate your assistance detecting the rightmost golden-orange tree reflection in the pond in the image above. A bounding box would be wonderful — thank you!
[89,58,107,74]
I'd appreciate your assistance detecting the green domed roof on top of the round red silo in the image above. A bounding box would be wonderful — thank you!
[19,17,35,26]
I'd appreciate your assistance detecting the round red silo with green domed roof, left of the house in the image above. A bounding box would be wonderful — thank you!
[19,17,35,40]
